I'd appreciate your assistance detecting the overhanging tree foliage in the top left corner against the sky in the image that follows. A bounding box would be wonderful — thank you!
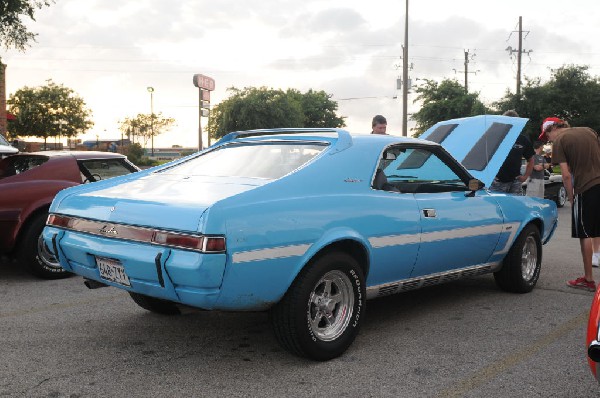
[0,0,54,51]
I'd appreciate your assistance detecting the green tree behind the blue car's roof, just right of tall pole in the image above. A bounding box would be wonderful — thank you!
[411,79,488,137]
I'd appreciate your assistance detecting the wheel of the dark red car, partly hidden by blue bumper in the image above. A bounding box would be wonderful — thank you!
[17,212,72,279]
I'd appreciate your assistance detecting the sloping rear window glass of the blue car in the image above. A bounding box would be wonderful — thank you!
[163,142,327,179]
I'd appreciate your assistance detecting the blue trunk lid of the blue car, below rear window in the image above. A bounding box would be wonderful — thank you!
[53,174,268,232]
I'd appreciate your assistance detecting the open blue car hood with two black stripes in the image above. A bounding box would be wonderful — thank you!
[419,115,529,187]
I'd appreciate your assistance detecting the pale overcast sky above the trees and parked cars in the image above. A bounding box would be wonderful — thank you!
[0,0,600,147]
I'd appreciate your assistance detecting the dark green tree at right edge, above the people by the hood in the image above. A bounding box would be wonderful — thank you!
[494,65,600,140]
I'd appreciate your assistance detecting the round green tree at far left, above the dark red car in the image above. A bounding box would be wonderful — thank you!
[6,80,94,142]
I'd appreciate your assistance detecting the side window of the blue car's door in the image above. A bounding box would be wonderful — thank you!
[376,146,468,193]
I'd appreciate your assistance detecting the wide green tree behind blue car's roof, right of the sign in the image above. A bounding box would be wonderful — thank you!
[207,87,344,139]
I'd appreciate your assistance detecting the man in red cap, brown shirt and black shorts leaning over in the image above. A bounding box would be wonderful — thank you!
[539,117,600,291]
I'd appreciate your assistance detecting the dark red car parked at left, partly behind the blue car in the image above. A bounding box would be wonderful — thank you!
[0,151,139,278]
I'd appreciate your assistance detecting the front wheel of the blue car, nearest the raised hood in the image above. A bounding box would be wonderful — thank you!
[494,224,542,293]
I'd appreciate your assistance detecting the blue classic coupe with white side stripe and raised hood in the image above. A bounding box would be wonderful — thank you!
[44,116,557,360]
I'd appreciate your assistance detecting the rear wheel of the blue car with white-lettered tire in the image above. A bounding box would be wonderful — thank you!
[269,252,366,361]
